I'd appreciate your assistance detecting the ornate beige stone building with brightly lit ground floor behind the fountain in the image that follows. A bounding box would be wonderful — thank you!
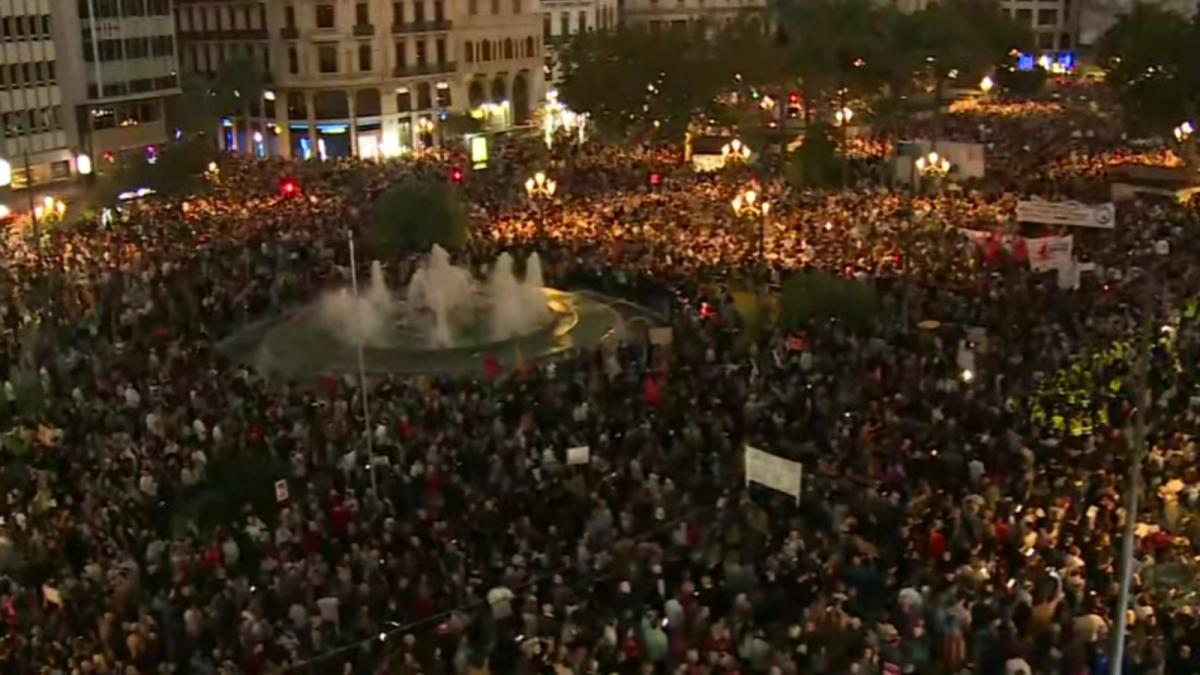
[176,0,544,157]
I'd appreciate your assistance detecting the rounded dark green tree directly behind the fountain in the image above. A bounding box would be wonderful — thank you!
[371,183,468,251]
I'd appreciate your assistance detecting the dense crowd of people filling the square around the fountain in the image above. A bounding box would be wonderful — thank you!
[0,88,1200,675]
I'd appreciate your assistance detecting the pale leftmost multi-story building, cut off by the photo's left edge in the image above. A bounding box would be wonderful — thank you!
[0,0,76,189]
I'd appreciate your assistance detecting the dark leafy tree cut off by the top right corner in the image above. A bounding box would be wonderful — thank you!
[1097,2,1200,133]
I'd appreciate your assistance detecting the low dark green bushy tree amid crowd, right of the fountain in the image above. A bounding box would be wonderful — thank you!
[780,270,880,330]
